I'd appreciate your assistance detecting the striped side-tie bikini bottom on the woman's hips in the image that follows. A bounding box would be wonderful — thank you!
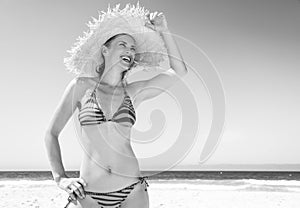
[68,176,149,208]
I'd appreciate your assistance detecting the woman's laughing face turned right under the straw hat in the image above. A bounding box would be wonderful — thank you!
[104,35,136,70]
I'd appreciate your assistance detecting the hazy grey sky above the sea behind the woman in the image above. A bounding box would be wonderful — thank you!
[0,0,300,170]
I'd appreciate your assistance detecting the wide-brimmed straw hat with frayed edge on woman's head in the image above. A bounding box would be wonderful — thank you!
[64,3,169,76]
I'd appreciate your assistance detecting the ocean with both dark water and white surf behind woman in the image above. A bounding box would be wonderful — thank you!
[0,171,300,193]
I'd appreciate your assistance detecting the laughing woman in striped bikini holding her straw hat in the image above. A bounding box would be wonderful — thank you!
[45,5,187,208]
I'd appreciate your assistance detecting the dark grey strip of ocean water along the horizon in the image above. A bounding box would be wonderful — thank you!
[0,171,300,181]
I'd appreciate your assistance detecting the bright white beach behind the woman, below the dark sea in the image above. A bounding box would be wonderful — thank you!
[0,180,300,208]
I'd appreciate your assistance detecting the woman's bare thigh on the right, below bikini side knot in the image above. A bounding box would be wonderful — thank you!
[121,183,149,208]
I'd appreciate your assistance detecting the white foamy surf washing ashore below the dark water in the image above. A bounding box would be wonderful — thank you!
[0,179,300,193]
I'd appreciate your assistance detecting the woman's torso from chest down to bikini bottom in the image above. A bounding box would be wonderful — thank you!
[77,78,141,192]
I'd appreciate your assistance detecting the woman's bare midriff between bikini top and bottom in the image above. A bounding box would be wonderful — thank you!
[80,122,141,192]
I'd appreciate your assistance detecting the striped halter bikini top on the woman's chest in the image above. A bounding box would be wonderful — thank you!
[78,82,136,126]
